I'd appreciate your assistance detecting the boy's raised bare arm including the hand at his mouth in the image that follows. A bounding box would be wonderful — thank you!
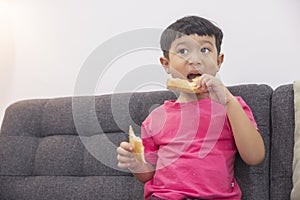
[196,74,265,165]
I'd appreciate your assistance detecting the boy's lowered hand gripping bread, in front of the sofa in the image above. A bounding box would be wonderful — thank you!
[117,142,143,171]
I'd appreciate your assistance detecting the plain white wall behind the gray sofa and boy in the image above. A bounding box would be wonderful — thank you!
[0,0,300,126]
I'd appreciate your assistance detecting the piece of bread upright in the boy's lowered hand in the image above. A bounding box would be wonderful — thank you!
[129,126,146,163]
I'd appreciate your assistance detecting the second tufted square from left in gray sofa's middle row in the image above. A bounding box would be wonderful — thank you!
[34,135,84,176]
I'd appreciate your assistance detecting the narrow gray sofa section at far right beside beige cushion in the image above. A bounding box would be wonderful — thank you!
[270,84,295,200]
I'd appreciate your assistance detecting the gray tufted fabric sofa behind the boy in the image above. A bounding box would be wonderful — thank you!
[0,84,294,200]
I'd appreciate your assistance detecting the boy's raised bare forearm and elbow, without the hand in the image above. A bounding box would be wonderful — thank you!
[224,88,265,165]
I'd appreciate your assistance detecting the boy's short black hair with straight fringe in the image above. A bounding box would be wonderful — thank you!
[160,16,223,59]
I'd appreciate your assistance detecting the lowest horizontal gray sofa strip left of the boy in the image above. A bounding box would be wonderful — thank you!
[0,176,143,200]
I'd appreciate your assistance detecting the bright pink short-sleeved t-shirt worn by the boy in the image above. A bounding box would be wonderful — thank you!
[142,97,257,200]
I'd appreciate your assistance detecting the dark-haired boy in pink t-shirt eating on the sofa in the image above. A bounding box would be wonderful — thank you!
[117,16,265,200]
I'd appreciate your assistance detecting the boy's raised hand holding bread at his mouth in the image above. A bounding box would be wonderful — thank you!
[196,74,228,105]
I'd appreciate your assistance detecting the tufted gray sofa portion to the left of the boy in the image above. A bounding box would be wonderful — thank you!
[0,92,175,200]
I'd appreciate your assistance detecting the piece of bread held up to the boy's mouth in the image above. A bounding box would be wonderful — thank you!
[167,77,207,94]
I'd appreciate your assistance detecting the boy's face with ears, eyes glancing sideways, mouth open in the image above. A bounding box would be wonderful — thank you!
[160,34,224,80]
